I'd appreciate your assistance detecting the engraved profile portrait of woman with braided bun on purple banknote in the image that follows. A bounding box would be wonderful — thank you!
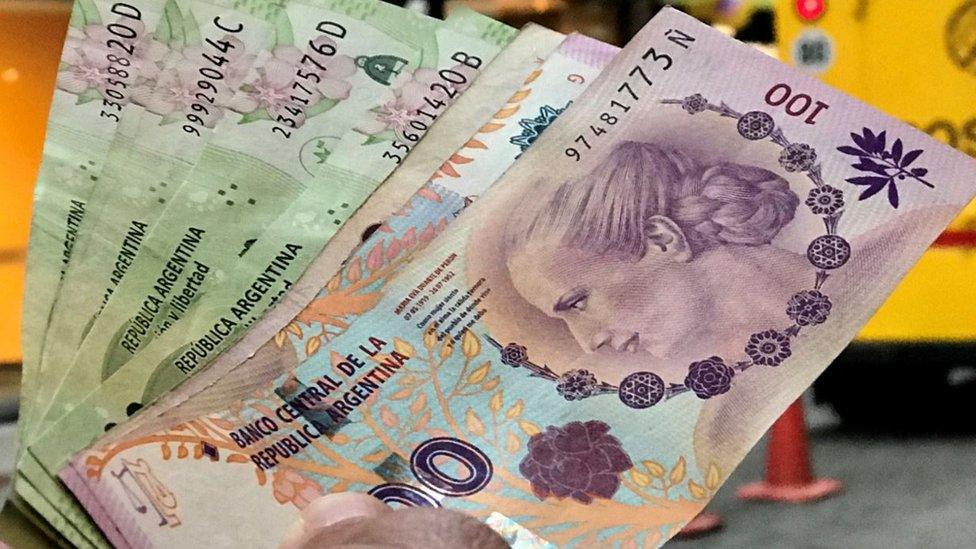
[467,109,940,468]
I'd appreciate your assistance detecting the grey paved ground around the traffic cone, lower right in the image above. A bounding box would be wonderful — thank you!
[669,429,976,549]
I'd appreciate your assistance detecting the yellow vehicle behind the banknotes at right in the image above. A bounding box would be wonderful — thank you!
[775,0,976,428]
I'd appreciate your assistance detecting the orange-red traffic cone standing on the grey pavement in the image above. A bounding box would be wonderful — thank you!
[736,399,843,503]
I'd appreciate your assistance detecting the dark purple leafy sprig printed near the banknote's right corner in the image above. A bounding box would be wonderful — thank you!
[837,128,935,208]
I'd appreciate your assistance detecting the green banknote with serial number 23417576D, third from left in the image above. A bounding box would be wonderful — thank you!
[33,0,450,430]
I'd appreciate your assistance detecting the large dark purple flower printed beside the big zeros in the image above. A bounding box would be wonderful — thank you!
[519,421,634,504]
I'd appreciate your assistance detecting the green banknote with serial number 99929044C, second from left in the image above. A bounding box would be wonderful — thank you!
[22,0,280,444]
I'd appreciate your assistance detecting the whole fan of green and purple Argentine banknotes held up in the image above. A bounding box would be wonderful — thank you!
[12,0,976,548]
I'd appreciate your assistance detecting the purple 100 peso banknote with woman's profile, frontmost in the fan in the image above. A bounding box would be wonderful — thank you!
[57,10,976,546]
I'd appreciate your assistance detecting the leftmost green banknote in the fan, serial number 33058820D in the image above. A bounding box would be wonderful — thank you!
[14,0,174,545]
